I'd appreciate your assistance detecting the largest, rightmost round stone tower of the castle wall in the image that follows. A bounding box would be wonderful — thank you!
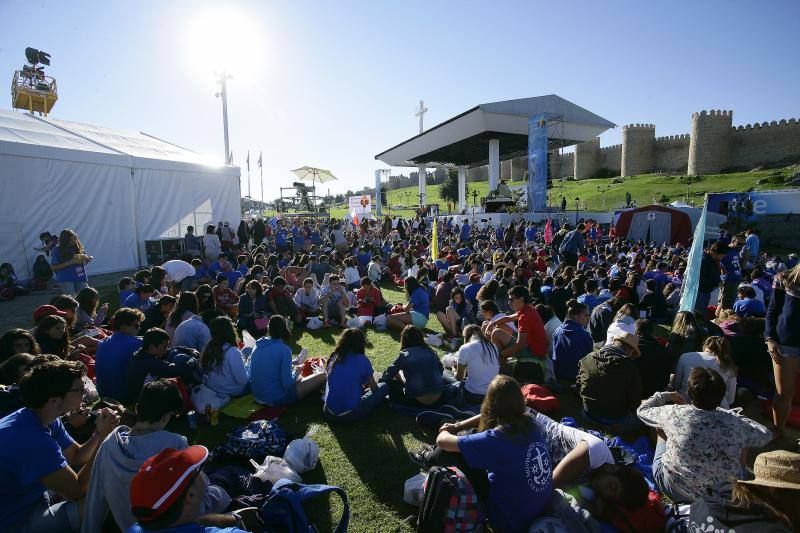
[688,110,733,175]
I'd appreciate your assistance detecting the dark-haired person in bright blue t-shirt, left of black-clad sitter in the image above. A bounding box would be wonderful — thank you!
[94,307,144,400]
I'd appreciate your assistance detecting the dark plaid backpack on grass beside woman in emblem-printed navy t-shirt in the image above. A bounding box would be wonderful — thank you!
[417,466,485,533]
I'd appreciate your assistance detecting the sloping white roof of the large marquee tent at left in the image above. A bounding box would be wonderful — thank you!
[0,110,240,176]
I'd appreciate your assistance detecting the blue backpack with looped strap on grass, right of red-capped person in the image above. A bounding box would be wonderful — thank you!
[259,479,350,533]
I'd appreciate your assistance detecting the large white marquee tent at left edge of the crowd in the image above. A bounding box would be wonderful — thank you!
[0,110,241,278]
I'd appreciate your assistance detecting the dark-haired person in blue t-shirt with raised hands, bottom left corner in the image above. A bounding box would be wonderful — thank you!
[0,361,119,531]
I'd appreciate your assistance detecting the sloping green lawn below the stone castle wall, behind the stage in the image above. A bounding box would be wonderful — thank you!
[260,169,797,218]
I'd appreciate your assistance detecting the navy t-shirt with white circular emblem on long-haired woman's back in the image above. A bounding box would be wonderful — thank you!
[458,426,553,533]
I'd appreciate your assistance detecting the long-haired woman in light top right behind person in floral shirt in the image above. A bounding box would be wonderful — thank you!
[672,336,739,409]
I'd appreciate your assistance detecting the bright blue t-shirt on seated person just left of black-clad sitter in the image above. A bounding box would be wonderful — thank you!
[94,331,142,402]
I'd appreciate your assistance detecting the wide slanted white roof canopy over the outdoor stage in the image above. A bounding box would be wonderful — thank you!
[375,94,616,167]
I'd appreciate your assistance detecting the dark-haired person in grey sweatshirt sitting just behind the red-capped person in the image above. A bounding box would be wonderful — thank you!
[83,379,232,531]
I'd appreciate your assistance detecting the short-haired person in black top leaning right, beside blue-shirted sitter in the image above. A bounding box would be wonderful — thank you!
[123,328,202,403]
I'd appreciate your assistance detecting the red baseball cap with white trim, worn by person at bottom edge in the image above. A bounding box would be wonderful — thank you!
[131,446,208,522]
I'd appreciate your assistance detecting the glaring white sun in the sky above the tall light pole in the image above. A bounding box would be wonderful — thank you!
[185,6,264,80]
